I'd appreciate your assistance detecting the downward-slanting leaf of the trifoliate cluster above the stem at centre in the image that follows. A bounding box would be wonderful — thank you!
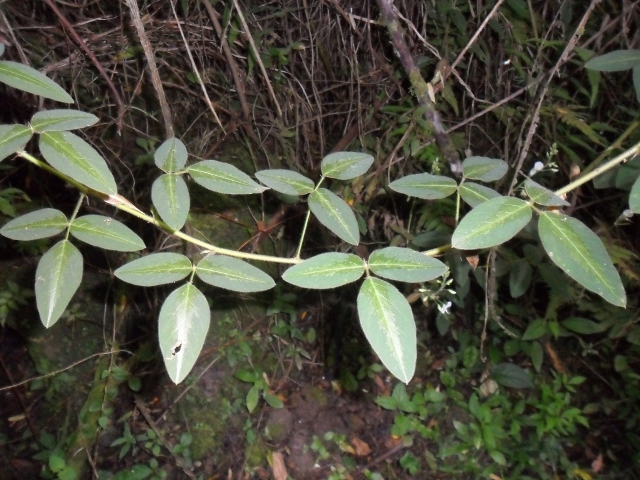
[309,188,360,245]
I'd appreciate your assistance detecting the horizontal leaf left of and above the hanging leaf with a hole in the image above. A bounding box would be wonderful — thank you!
[113,252,193,287]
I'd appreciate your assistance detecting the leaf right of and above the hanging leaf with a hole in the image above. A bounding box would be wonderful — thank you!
[196,255,276,293]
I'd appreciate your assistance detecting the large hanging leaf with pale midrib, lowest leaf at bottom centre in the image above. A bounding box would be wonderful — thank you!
[358,278,417,383]
